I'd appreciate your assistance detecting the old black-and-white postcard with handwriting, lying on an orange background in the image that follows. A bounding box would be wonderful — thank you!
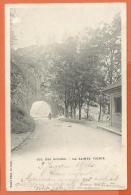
[5,3,127,191]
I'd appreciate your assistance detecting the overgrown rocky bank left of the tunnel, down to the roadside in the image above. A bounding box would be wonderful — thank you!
[11,48,40,133]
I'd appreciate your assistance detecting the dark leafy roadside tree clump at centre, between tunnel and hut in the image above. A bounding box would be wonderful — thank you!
[43,34,104,120]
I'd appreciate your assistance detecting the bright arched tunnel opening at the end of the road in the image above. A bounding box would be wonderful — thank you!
[30,101,51,118]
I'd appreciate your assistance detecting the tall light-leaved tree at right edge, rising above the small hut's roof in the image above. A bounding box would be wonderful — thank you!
[95,14,121,84]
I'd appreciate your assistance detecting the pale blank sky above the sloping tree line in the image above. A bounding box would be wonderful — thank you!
[10,3,124,48]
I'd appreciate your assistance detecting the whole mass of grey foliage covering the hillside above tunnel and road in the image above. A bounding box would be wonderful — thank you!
[11,14,121,122]
